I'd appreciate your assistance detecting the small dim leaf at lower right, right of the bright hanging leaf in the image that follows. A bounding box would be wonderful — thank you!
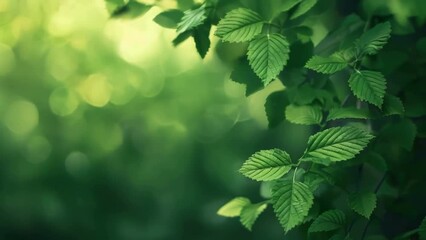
[349,192,377,219]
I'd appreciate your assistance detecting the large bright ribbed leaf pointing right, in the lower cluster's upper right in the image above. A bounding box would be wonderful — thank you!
[305,127,374,162]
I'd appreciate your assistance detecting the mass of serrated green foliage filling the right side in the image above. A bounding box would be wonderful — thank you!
[51,0,426,239]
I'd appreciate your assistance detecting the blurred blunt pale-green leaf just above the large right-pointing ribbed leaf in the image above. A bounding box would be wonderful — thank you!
[285,104,322,125]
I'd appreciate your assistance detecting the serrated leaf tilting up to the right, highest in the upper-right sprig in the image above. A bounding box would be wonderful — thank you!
[356,22,392,55]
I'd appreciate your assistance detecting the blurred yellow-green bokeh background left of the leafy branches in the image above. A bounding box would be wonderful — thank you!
[0,0,424,240]
